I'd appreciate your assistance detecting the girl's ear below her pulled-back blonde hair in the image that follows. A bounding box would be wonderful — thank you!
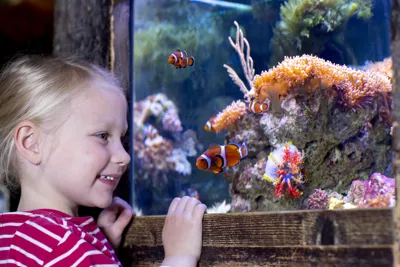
[14,121,41,165]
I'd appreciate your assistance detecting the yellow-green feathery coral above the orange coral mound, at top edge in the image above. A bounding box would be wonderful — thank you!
[270,0,372,65]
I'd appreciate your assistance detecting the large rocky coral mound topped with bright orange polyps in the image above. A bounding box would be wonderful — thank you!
[217,23,392,212]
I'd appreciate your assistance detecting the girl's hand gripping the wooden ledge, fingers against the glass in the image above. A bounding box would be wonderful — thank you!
[162,196,207,267]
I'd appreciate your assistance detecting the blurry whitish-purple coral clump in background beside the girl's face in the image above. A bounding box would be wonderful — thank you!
[134,93,202,188]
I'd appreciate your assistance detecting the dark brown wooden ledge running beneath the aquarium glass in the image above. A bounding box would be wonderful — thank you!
[120,209,393,266]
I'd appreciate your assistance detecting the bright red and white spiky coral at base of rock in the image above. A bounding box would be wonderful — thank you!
[264,143,304,199]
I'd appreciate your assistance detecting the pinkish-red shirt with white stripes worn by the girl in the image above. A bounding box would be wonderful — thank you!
[0,209,122,267]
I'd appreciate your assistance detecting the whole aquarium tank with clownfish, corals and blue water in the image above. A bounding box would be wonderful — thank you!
[113,0,395,215]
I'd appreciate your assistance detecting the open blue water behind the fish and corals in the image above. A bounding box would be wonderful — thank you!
[115,0,391,214]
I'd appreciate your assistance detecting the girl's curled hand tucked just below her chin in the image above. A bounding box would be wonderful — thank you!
[97,197,134,250]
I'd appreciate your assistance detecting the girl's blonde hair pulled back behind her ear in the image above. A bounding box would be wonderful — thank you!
[0,56,125,188]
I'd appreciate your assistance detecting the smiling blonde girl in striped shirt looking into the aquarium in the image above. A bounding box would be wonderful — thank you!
[0,56,206,266]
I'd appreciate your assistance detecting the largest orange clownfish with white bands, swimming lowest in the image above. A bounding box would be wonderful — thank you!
[196,142,248,174]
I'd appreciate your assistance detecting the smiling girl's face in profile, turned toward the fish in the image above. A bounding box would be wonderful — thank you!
[41,85,130,209]
